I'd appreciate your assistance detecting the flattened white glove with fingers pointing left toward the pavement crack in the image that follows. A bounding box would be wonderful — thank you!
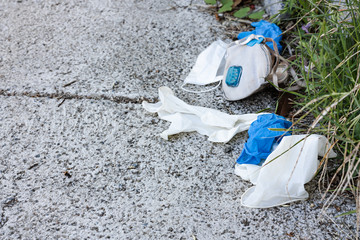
[142,87,260,143]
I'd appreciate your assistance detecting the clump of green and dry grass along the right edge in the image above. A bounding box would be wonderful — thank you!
[281,0,360,232]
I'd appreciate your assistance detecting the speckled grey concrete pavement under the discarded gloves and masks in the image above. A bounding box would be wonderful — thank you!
[0,0,355,240]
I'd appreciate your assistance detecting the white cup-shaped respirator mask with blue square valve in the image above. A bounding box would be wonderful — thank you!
[222,35,288,101]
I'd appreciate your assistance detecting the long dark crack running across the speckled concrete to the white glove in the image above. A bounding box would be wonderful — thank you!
[0,89,158,106]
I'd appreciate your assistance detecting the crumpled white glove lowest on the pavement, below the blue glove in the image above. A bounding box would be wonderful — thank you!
[235,134,336,208]
